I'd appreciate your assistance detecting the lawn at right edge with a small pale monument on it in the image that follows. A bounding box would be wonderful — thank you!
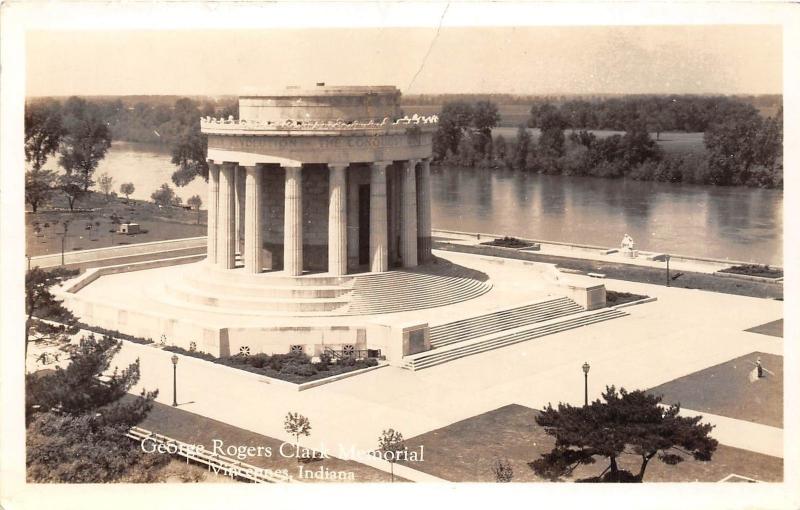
[649,352,783,427]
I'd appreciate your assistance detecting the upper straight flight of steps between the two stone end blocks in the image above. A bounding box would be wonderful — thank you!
[430,297,583,348]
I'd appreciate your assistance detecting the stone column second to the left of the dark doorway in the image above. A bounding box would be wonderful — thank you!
[283,166,303,276]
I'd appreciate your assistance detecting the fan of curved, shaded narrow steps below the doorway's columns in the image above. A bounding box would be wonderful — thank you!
[348,270,492,315]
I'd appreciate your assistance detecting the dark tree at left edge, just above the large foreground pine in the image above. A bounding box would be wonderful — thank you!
[25,267,77,358]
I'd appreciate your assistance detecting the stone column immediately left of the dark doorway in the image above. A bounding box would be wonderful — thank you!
[328,165,347,276]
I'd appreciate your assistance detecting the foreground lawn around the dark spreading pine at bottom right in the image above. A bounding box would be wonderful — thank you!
[406,404,783,482]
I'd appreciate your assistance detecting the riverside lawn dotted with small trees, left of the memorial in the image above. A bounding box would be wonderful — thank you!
[25,192,206,257]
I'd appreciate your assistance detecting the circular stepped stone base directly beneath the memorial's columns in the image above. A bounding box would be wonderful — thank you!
[149,259,492,317]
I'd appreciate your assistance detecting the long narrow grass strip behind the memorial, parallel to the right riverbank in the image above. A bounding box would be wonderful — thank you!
[434,242,783,299]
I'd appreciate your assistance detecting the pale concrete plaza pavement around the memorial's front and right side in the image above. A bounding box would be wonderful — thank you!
[97,253,783,481]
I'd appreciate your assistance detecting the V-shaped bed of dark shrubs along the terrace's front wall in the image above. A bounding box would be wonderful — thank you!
[164,346,378,384]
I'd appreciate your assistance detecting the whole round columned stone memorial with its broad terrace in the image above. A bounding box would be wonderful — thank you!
[60,86,621,368]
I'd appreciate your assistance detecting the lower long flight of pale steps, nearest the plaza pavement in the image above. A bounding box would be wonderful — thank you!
[402,308,627,370]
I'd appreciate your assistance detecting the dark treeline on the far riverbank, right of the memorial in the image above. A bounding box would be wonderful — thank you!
[433,97,783,188]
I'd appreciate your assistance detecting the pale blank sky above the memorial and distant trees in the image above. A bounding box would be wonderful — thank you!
[26,25,783,96]
